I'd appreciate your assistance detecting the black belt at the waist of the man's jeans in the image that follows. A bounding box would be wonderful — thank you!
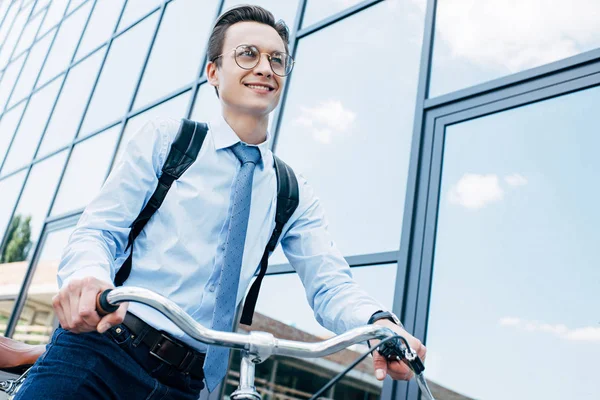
[123,313,206,379]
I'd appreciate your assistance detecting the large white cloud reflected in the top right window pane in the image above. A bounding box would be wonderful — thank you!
[436,0,600,72]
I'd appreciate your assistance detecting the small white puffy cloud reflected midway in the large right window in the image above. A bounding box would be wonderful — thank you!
[448,174,503,209]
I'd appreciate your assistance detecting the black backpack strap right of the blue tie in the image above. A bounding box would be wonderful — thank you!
[240,155,300,325]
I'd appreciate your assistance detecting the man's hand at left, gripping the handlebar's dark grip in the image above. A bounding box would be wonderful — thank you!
[52,277,129,333]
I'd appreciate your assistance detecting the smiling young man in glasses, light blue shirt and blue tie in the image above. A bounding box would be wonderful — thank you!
[17,6,425,399]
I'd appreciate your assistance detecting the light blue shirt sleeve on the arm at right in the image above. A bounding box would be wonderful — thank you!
[281,175,386,334]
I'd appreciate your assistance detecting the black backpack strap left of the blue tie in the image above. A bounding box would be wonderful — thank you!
[115,118,208,286]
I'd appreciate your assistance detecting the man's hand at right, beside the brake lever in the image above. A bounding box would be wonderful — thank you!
[371,319,427,381]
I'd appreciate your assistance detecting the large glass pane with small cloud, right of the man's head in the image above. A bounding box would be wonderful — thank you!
[276,2,424,255]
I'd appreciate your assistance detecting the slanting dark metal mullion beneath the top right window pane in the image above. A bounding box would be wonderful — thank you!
[425,49,600,109]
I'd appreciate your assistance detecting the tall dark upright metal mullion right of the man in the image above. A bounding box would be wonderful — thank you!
[384,0,437,400]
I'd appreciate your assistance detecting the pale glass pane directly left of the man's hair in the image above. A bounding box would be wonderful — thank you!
[134,0,217,108]
